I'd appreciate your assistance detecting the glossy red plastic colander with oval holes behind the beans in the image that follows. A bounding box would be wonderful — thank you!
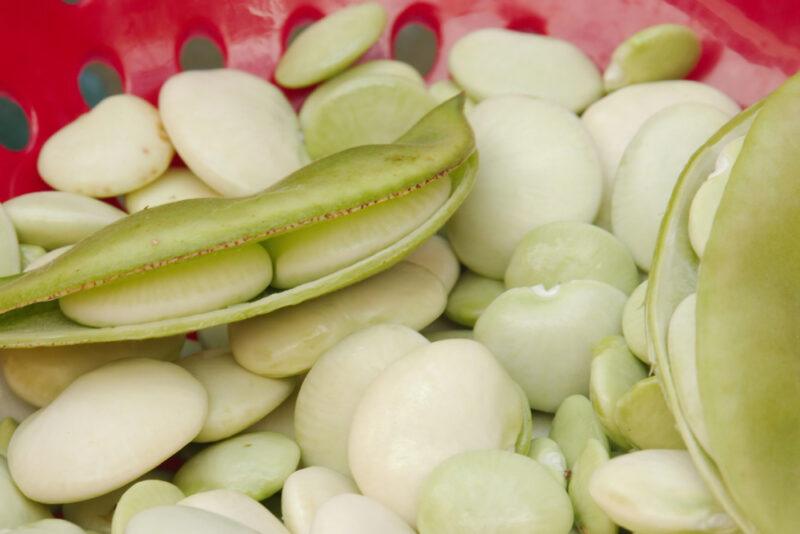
[0,0,800,200]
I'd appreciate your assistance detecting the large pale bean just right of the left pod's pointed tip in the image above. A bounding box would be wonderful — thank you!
[447,96,603,280]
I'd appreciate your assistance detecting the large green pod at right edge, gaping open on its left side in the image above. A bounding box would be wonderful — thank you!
[647,72,800,533]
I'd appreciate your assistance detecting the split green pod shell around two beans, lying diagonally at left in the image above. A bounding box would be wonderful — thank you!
[0,96,477,348]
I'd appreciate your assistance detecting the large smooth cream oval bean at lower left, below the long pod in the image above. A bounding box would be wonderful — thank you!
[8,359,208,503]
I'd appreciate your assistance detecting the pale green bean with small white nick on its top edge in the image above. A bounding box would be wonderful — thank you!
[475,280,625,412]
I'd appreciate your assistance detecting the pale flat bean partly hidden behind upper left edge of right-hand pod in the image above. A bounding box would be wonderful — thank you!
[611,103,731,271]
